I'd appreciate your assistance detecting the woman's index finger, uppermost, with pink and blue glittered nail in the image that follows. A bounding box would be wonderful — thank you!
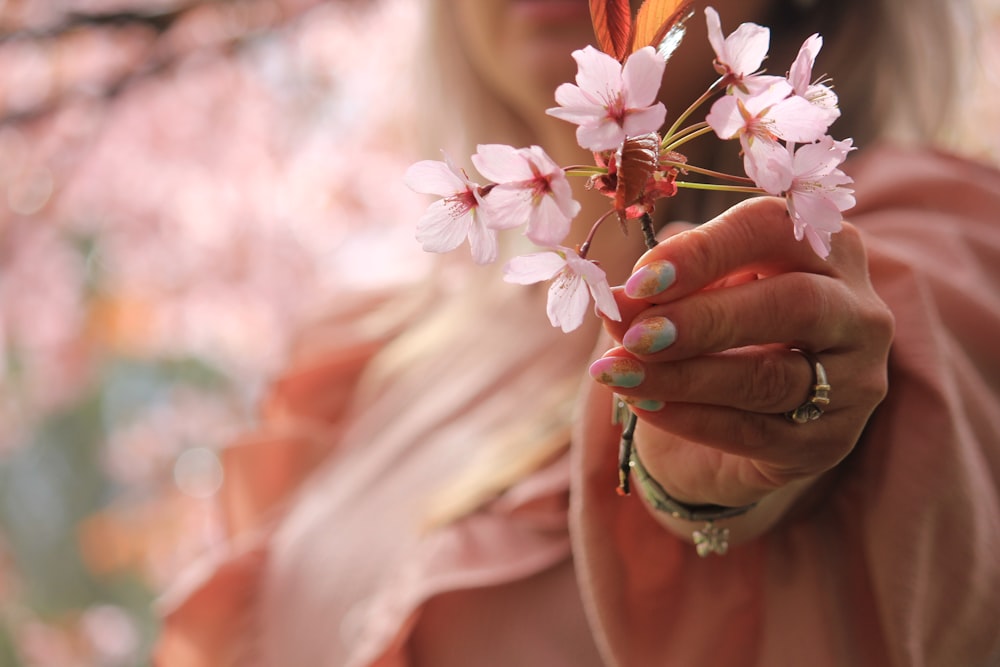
[625,197,834,303]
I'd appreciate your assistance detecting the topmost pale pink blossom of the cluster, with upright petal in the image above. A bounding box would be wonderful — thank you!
[705,7,778,94]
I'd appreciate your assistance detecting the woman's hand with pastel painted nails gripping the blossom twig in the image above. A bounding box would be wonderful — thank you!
[591,197,893,520]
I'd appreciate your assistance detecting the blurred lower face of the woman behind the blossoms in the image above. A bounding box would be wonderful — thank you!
[443,0,771,120]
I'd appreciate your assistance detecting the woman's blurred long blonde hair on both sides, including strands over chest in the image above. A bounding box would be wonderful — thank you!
[386,0,971,525]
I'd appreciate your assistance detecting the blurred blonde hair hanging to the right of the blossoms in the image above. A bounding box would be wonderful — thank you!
[770,0,978,147]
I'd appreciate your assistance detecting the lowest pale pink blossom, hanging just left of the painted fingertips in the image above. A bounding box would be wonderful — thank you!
[504,246,621,333]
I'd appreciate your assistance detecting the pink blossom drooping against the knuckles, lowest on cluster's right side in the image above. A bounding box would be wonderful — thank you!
[768,137,854,257]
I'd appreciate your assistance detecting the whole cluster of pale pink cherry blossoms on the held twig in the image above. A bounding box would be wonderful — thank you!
[405,2,854,331]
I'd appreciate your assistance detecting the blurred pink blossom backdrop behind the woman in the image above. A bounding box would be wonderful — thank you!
[0,0,1000,667]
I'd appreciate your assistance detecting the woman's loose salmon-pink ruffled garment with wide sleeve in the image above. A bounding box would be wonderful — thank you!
[156,149,1000,667]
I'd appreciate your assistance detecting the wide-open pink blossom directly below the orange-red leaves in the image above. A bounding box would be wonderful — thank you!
[546,46,667,151]
